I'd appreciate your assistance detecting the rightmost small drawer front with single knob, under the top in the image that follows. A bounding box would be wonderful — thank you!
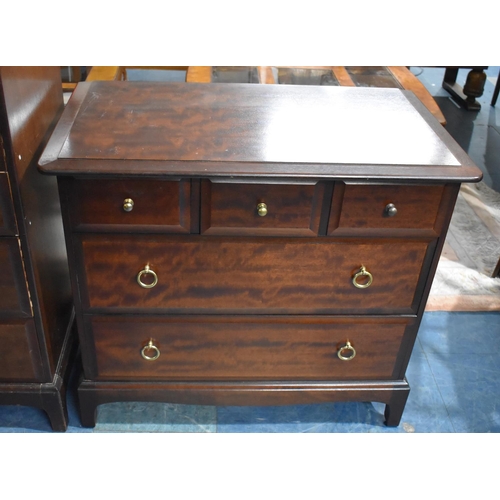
[328,183,444,235]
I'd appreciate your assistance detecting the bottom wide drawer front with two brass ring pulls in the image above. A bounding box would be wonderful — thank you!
[86,316,408,380]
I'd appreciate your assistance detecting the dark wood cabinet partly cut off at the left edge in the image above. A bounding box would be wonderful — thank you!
[0,67,76,431]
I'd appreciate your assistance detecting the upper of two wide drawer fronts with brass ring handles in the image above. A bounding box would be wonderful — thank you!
[76,234,433,314]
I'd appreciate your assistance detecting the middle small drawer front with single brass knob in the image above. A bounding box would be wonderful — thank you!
[201,180,329,236]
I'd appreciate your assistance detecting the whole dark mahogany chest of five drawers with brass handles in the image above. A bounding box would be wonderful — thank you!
[40,81,481,426]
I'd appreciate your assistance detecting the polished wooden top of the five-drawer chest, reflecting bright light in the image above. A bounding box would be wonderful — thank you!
[40,81,481,182]
